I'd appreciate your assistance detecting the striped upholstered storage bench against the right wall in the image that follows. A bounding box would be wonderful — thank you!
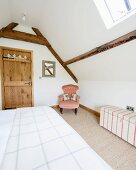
[100,106,136,146]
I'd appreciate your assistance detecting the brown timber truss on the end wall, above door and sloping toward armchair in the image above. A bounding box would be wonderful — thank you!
[0,23,78,83]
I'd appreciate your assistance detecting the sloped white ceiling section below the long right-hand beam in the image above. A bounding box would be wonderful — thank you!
[69,40,136,82]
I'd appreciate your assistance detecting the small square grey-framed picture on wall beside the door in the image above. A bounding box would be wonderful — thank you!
[42,60,56,77]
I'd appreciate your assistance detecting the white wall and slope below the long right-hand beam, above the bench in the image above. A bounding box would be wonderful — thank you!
[69,40,136,111]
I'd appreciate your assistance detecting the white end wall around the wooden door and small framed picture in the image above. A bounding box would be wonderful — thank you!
[0,38,75,109]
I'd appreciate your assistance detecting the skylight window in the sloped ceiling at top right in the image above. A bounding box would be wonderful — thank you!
[94,0,136,29]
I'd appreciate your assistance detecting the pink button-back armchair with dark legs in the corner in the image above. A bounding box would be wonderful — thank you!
[59,84,80,114]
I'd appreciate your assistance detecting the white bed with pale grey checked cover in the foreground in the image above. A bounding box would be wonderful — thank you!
[0,106,112,170]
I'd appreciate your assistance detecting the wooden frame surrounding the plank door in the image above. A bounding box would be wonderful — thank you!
[0,46,34,110]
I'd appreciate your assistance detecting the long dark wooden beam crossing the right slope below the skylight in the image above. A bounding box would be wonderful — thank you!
[64,30,136,65]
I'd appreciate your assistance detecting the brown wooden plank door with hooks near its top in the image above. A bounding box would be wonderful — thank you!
[2,48,33,109]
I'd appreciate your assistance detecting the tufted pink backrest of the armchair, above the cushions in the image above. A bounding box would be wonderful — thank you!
[62,84,78,97]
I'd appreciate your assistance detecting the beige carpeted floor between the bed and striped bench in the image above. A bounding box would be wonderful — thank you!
[56,108,136,170]
